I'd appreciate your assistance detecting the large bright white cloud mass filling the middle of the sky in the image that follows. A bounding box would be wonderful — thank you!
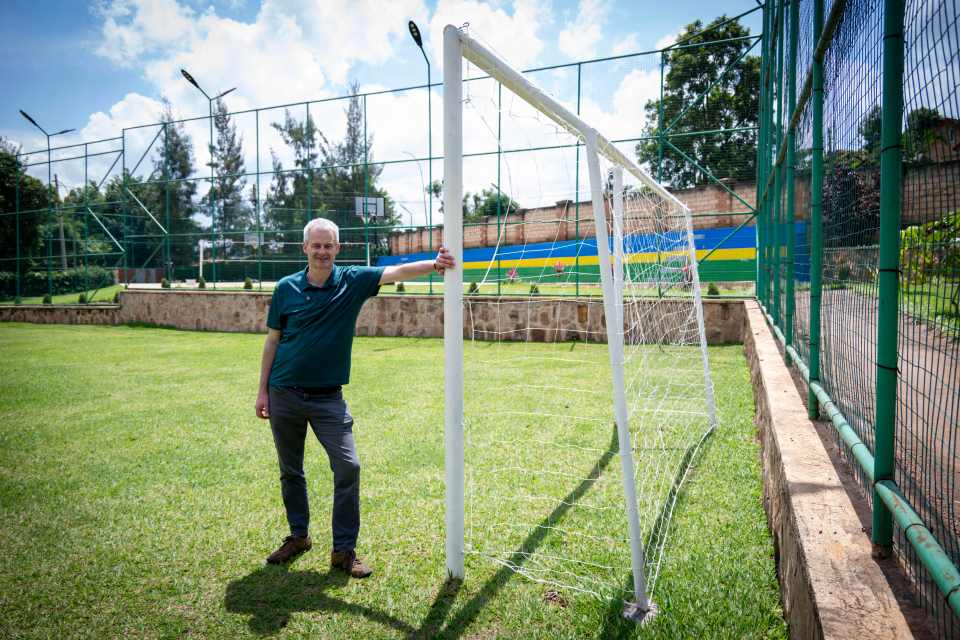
[54,0,659,223]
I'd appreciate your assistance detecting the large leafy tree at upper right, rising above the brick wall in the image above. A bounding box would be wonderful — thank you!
[636,16,760,189]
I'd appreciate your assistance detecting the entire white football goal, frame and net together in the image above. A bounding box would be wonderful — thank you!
[444,27,716,618]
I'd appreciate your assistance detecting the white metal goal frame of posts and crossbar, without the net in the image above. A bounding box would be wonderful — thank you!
[443,25,716,620]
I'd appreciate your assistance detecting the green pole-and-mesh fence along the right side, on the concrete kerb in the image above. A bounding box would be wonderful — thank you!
[758,0,960,638]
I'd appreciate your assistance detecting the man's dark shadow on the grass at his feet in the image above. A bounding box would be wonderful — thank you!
[224,566,416,636]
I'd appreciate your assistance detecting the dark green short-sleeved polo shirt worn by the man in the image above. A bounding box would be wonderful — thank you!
[267,265,383,388]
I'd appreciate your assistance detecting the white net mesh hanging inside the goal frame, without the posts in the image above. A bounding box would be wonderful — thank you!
[464,48,711,599]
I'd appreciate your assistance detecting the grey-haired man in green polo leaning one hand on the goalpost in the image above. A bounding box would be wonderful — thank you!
[256,218,454,578]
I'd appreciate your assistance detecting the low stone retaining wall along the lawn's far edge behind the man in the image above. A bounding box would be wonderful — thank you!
[0,289,743,344]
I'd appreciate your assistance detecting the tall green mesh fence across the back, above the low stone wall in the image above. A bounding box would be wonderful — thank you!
[0,8,760,302]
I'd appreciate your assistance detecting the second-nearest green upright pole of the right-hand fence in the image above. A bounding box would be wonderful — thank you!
[807,0,823,420]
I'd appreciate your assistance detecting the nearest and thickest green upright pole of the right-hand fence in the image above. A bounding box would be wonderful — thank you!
[872,0,904,556]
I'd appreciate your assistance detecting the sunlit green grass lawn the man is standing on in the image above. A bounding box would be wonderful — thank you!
[0,324,787,639]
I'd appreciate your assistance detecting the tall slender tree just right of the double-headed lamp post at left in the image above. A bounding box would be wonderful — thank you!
[203,98,252,239]
